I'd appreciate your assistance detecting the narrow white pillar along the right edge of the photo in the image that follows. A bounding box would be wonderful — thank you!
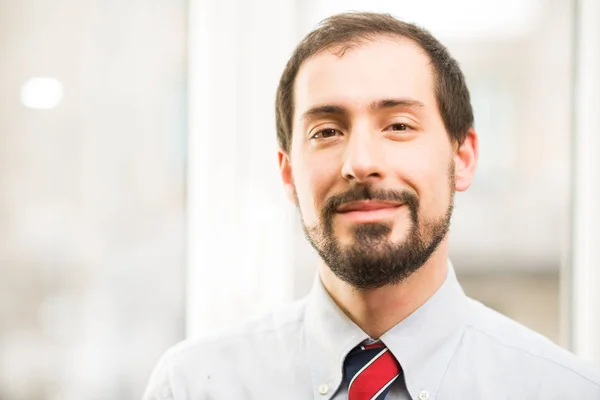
[565,0,600,364]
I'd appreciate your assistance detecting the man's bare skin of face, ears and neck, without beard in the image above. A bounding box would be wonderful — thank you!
[278,37,478,339]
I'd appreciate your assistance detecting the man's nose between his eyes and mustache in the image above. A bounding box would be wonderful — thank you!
[342,132,384,183]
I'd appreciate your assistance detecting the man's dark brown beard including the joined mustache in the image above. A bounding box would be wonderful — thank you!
[302,165,454,290]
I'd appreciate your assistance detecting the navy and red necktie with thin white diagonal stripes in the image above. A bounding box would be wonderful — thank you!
[344,342,400,400]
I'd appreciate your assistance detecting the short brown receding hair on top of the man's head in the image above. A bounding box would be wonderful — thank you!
[275,12,473,153]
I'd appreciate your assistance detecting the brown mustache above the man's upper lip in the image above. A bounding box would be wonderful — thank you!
[322,185,419,217]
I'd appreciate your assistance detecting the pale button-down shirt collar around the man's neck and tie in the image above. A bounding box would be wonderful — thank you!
[305,262,468,400]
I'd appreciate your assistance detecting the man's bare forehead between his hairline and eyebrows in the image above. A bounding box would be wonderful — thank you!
[294,37,436,120]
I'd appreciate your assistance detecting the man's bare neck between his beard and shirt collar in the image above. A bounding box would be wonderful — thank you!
[319,240,448,339]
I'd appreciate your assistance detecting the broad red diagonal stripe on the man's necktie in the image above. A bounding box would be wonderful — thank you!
[348,349,400,400]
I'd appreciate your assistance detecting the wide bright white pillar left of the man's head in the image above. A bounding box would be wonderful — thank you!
[186,0,298,336]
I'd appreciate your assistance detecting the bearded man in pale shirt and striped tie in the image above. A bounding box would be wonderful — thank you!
[145,13,600,400]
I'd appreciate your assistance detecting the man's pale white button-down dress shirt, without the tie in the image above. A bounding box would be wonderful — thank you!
[144,263,600,400]
